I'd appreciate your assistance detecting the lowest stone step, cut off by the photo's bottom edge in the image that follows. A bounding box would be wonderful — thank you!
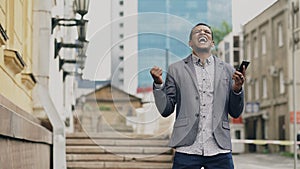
[67,161,172,169]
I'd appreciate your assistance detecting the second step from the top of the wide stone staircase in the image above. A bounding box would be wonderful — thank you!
[66,138,169,147]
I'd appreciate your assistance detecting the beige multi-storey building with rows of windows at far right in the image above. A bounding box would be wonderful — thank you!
[243,0,300,152]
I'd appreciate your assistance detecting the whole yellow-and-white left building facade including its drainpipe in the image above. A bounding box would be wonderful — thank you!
[0,0,91,169]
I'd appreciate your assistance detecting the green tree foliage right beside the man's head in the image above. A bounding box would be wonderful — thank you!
[212,21,232,48]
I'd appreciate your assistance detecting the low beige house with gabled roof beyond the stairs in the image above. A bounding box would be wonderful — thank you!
[75,84,142,133]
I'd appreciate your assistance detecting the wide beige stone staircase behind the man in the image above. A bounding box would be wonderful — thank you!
[66,133,173,169]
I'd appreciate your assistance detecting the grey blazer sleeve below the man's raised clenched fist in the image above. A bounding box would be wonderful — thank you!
[153,66,178,117]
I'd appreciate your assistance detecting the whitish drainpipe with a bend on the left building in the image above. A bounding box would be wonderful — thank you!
[32,0,66,169]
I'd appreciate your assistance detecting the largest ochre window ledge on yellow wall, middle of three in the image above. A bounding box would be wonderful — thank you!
[4,49,26,74]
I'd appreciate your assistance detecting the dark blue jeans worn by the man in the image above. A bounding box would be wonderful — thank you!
[173,152,234,169]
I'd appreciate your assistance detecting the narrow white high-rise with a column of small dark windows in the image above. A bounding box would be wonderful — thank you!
[105,0,138,94]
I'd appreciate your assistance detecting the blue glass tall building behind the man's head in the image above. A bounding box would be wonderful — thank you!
[138,0,232,88]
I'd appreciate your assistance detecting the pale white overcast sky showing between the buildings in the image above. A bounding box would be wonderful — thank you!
[83,0,276,80]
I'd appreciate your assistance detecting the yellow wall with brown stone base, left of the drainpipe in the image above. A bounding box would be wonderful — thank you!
[0,0,53,169]
